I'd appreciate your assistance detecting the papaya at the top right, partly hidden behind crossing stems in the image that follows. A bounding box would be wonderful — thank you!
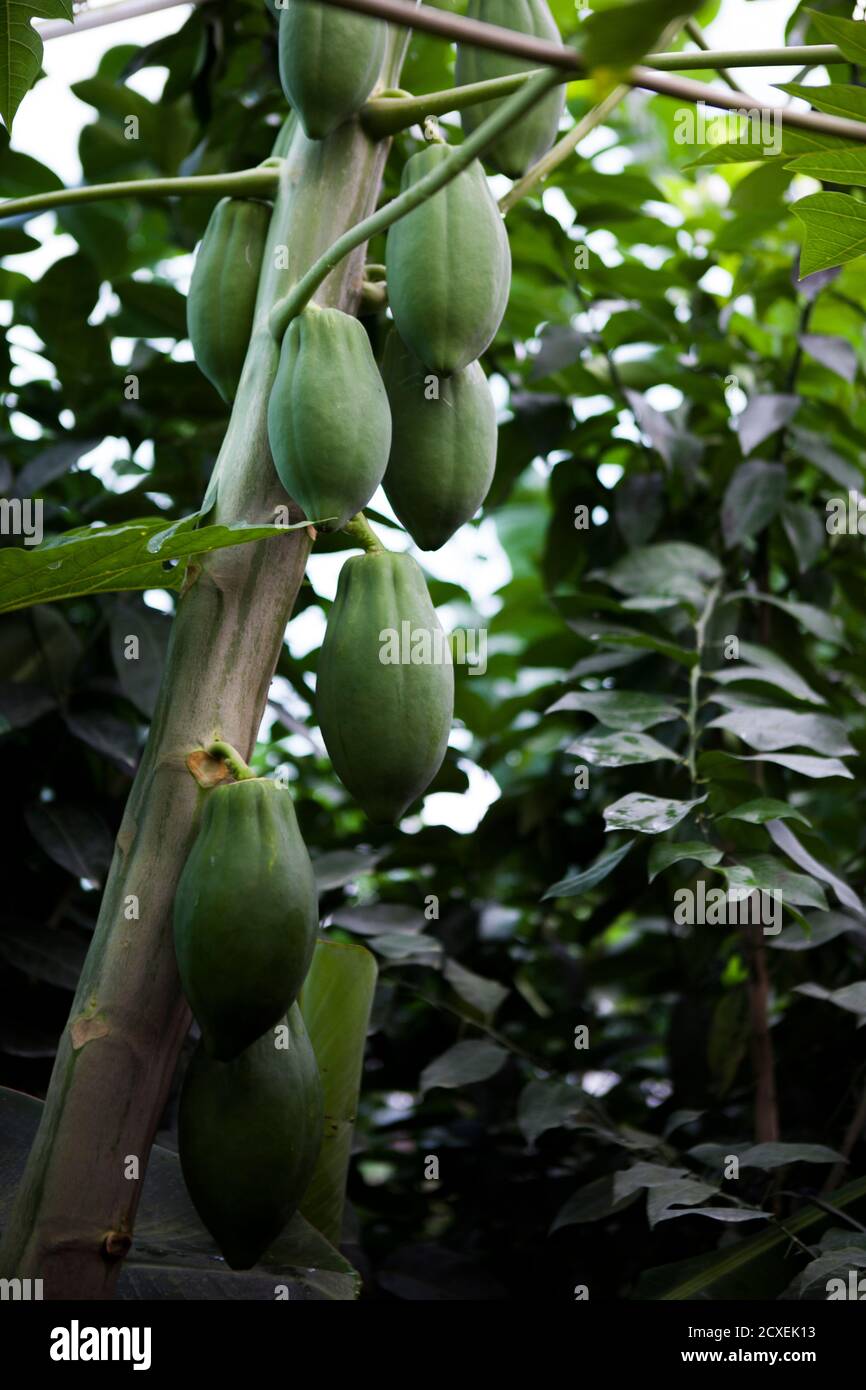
[456,0,566,178]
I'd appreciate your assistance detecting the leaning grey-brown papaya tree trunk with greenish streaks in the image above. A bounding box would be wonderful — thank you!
[0,38,405,1298]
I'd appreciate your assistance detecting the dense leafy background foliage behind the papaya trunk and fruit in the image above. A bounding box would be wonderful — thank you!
[0,0,866,1298]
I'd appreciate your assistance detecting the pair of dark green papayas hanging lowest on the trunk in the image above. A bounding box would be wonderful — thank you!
[174,765,324,1269]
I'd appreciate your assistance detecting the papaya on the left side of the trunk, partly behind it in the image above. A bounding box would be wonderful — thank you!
[186,197,271,404]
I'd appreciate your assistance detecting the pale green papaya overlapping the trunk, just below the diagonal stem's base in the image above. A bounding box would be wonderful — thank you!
[268,304,391,531]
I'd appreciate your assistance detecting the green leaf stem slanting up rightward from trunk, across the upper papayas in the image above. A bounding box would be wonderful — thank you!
[270,70,559,342]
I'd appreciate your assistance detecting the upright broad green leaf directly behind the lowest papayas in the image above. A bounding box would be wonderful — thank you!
[299,941,377,1245]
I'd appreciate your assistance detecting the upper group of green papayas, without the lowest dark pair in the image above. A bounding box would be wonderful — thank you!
[189,0,564,820]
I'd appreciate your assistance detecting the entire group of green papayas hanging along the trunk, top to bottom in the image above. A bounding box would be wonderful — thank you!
[174,0,562,1269]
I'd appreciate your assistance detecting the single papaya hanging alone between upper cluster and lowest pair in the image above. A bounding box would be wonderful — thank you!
[316,550,455,821]
